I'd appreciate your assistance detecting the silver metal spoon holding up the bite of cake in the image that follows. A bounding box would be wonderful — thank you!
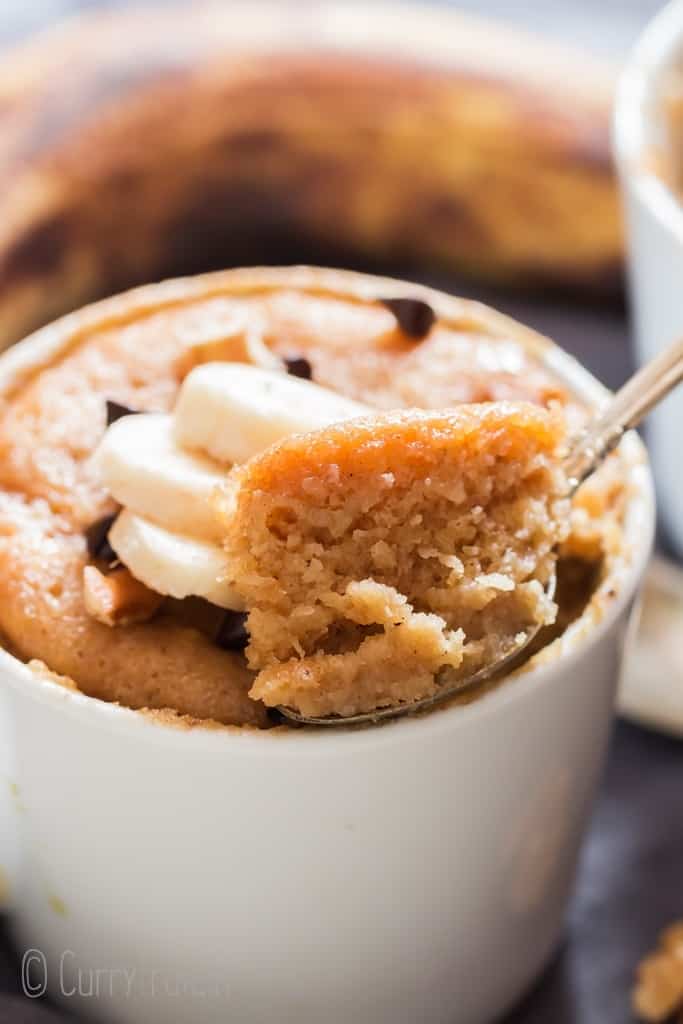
[278,339,683,726]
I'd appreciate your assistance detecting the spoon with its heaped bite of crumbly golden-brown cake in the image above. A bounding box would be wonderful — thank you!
[218,333,683,725]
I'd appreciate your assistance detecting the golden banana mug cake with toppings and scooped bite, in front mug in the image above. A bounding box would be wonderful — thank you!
[0,268,629,728]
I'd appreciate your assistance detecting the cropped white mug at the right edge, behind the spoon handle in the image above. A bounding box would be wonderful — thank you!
[614,0,683,556]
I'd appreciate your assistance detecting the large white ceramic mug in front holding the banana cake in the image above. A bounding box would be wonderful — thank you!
[0,286,654,1024]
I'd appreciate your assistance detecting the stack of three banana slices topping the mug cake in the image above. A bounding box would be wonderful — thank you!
[94,362,370,611]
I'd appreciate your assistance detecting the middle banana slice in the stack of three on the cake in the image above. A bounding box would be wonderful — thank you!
[94,413,225,544]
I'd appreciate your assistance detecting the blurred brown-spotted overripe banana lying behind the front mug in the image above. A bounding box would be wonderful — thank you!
[0,0,623,348]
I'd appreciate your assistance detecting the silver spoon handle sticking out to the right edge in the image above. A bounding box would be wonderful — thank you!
[564,329,683,485]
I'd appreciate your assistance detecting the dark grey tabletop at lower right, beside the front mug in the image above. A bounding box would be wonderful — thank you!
[507,723,683,1024]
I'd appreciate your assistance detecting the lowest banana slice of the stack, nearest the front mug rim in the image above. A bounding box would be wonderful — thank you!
[109,509,244,611]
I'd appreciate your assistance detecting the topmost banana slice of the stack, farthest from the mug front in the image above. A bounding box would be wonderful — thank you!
[174,362,370,463]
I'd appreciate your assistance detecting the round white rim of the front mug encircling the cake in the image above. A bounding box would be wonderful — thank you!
[0,266,655,757]
